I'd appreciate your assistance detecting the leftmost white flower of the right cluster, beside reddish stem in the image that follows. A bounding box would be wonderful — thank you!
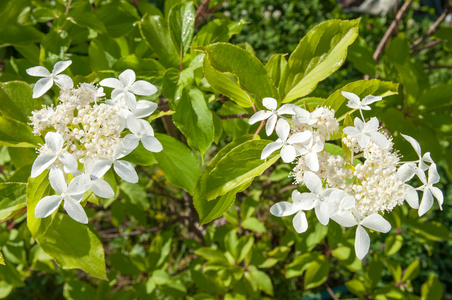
[248,97,295,135]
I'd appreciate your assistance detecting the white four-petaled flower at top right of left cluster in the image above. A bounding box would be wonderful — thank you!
[99,69,157,112]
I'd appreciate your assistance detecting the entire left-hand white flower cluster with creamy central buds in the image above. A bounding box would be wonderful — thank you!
[27,61,163,224]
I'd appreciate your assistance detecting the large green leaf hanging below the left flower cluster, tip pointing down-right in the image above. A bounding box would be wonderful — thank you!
[37,214,107,280]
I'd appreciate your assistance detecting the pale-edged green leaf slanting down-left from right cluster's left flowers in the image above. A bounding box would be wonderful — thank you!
[199,140,279,200]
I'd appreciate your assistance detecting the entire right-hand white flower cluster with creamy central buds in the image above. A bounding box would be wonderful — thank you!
[249,92,443,259]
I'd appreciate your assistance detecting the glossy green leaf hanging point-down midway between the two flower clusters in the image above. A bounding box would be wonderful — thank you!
[173,86,214,156]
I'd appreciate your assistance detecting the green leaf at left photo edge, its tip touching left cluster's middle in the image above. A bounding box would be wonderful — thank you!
[0,116,43,148]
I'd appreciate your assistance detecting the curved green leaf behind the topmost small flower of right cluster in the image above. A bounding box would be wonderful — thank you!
[323,79,399,116]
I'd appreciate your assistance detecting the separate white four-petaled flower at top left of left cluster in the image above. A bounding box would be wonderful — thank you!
[26,60,74,98]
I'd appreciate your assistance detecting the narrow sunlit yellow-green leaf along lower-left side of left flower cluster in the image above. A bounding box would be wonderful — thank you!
[27,171,55,239]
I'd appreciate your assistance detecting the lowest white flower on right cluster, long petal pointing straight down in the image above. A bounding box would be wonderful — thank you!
[331,209,391,260]
